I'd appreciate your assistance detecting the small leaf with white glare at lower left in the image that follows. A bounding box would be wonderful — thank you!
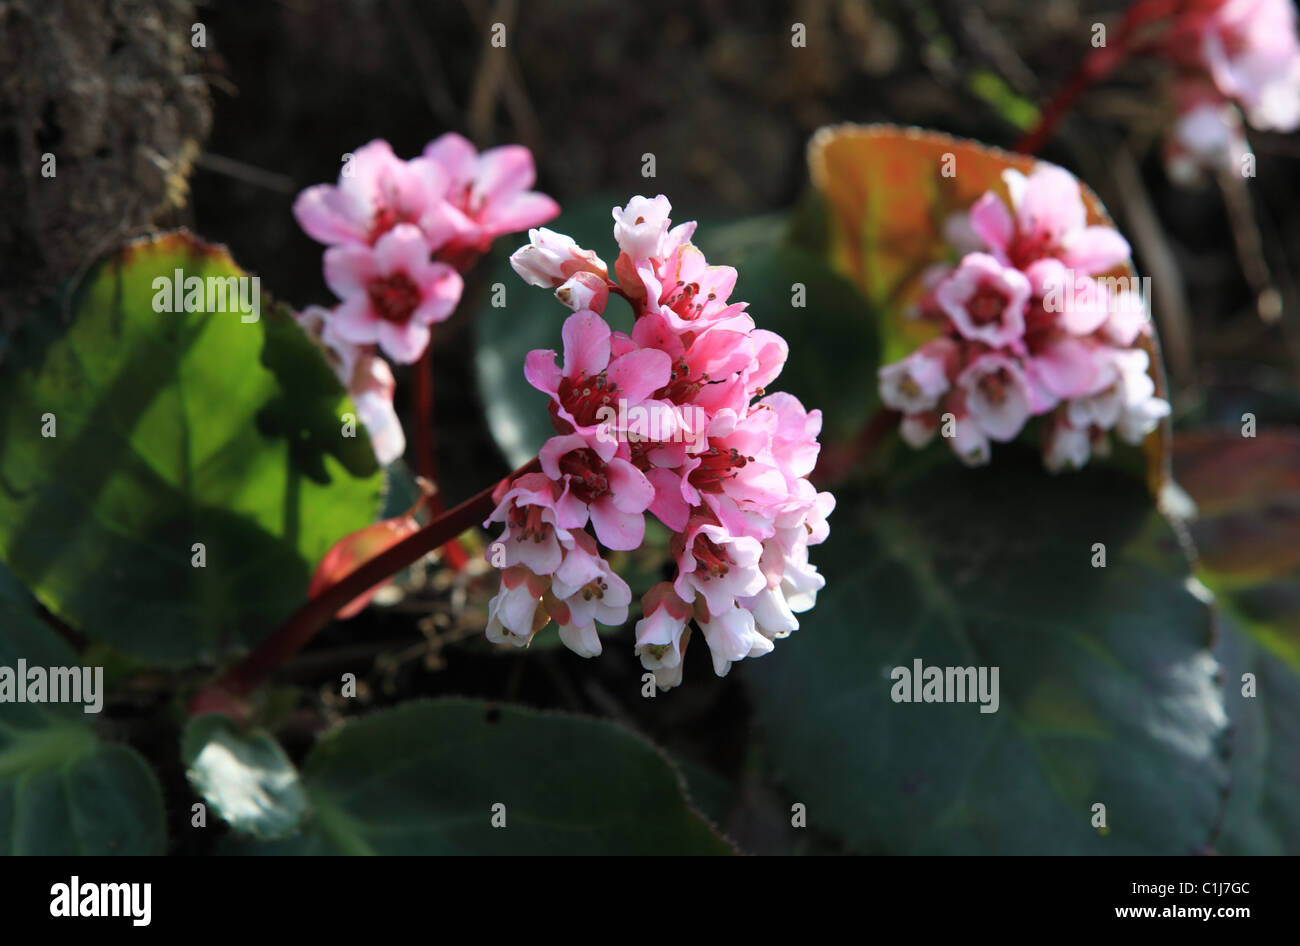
[181,713,308,838]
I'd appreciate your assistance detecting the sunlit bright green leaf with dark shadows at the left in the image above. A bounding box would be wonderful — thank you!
[0,233,382,664]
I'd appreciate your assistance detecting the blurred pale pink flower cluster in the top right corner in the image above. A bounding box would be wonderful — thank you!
[1164,0,1300,181]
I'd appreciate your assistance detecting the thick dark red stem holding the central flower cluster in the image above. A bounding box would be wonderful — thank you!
[190,459,538,719]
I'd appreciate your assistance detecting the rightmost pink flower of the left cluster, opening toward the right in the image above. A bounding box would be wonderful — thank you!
[424,131,559,262]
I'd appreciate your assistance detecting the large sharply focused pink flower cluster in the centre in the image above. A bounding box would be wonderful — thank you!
[488,195,835,689]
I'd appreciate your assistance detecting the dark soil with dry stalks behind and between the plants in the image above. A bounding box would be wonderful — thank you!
[0,0,1300,852]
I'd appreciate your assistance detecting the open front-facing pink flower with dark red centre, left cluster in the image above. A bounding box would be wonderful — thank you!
[325,224,462,364]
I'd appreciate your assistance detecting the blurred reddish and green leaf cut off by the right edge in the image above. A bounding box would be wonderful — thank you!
[1174,428,1300,854]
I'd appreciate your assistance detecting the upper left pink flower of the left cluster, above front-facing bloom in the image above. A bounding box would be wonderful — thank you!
[294,140,458,252]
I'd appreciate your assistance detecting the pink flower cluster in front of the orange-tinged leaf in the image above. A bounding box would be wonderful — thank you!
[880,165,1169,470]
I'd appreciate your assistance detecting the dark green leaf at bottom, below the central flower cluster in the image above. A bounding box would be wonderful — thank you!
[228,699,732,854]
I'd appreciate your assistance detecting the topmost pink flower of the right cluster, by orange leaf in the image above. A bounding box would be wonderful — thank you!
[971,164,1128,275]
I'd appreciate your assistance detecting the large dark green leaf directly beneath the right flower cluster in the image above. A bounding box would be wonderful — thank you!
[744,447,1226,854]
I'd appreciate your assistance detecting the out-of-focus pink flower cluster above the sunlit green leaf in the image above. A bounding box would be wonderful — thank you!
[294,133,559,464]
